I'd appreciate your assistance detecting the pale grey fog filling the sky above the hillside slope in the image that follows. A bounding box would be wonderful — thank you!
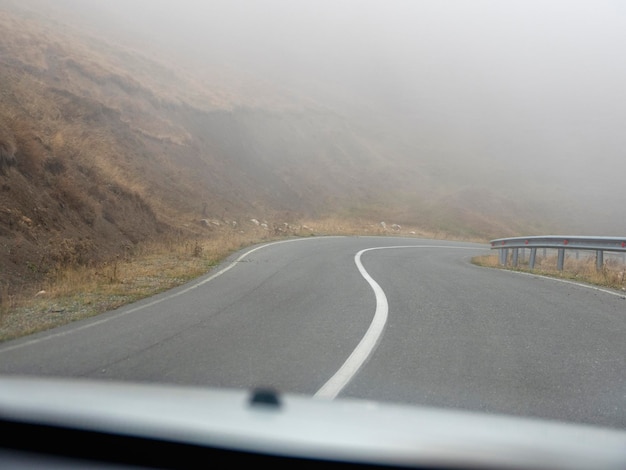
[34,0,626,230]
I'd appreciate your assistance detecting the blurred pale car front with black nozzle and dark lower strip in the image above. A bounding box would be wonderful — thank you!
[0,376,626,469]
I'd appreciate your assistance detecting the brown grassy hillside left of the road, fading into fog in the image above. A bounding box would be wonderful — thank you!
[0,1,564,294]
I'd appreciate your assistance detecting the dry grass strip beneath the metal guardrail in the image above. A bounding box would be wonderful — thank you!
[472,254,626,291]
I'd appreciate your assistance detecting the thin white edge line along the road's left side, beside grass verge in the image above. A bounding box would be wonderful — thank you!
[0,237,331,354]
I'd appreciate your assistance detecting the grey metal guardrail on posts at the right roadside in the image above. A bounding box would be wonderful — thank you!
[490,235,626,271]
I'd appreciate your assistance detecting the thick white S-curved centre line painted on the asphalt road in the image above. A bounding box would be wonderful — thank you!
[314,245,485,400]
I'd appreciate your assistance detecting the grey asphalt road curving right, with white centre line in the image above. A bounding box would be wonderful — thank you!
[0,237,626,429]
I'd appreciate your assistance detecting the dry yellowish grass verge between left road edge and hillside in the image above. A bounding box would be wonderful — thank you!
[0,226,267,341]
